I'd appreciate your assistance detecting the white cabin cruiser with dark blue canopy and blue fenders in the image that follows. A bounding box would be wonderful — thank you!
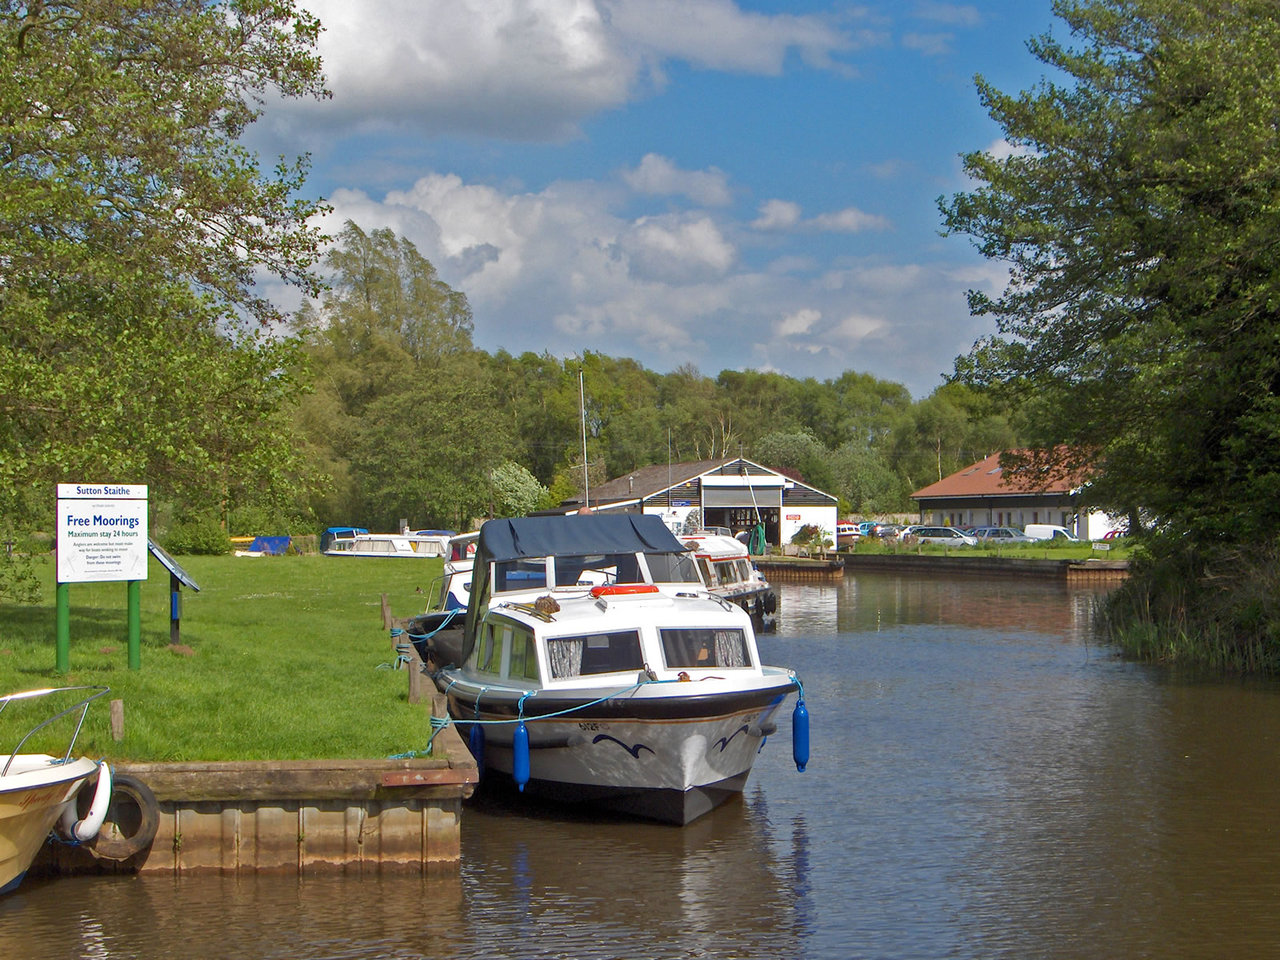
[433,515,809,824]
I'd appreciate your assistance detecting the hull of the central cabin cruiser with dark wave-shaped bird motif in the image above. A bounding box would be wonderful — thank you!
[447,678,795,824]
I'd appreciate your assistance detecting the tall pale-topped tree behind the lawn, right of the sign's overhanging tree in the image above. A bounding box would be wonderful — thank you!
[296,221,511,529]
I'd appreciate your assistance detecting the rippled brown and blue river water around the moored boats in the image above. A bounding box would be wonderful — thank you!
[0,573,1280,960]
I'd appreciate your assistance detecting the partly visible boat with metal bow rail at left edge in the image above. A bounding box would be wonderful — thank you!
[0,686,111,893]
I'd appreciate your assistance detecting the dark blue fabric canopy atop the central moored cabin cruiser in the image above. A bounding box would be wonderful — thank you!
[476,513,686,568]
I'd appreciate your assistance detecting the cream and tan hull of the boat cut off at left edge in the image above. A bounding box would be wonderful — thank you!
[0,754,97,893]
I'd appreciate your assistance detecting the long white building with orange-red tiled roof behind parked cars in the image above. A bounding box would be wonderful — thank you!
[911,453,1121,540]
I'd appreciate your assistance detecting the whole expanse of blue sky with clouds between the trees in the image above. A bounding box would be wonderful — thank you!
[250,0,1064,399]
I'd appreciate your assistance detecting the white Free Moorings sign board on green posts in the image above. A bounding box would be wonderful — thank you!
[58,484,147,584]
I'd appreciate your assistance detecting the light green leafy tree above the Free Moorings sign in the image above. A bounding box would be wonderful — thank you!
[0,0,324,563]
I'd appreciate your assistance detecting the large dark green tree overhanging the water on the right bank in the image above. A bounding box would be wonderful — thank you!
[942,0,1280,665]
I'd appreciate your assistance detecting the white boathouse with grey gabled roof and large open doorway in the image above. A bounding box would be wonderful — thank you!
[557,457,838,547]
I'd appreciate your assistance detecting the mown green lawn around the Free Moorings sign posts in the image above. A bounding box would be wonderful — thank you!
[0,556,440,762]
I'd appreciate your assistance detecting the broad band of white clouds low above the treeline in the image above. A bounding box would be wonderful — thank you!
[317,173,1001,396]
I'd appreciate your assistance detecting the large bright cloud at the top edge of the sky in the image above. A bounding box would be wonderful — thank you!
[277,0,858,142]
